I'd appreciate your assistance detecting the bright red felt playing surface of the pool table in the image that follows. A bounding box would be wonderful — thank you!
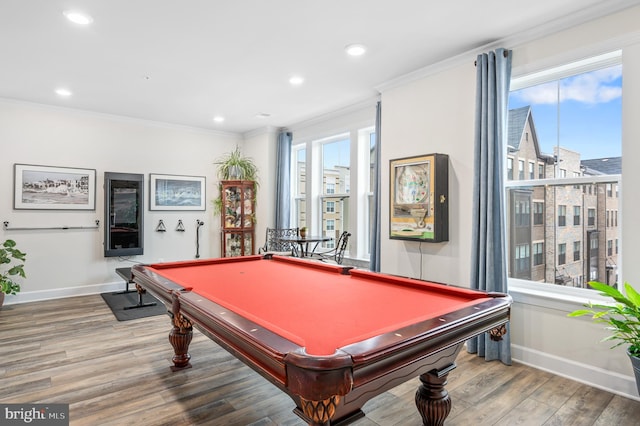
[150,256,487,355]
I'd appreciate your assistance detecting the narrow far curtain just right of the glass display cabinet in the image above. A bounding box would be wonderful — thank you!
[275,131,293,229]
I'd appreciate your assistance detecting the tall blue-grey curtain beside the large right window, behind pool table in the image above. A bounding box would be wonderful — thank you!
[467,49,512,365]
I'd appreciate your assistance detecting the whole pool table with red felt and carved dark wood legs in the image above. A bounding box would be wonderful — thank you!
[132,255,511,425]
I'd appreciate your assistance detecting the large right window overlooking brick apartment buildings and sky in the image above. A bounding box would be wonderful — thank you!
[505,52,622,288]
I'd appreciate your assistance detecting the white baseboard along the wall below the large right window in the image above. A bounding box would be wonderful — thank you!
[511,344,640,401]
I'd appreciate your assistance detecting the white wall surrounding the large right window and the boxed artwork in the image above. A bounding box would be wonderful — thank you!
[381,8,640,398]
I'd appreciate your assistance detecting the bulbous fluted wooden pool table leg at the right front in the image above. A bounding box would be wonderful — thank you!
[416,364,456,426]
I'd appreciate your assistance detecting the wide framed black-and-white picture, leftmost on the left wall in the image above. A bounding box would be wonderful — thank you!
[13,164,96,210]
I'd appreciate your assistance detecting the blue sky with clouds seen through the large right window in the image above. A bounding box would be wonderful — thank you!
[509,65,622,160]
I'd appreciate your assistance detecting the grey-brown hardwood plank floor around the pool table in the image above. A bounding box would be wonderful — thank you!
[0,295,640,426]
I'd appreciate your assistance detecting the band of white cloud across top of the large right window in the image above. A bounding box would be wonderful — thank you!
[516,66,622,105]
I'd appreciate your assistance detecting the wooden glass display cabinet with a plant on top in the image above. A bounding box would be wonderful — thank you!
[220,180,256,257]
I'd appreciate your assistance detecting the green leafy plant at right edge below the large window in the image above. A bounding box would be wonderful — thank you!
[569,281,640,393]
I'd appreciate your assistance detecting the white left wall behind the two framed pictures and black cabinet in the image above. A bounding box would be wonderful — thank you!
[0,100,242,304]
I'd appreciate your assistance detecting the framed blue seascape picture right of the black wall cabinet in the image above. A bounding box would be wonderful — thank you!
[149,174,206,210]
